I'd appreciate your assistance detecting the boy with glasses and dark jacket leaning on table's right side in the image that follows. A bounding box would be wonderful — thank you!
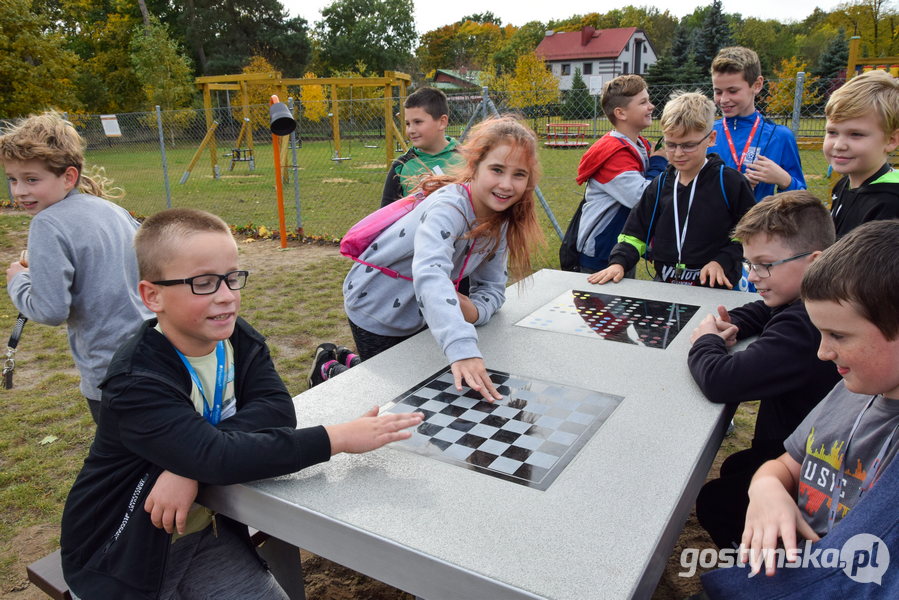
[688,190,840,548]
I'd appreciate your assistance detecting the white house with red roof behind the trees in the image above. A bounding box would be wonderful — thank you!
[535,27,657,94]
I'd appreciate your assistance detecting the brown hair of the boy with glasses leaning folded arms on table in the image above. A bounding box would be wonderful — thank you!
[732,190,836,253]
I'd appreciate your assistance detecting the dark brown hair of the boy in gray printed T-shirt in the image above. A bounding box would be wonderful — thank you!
[801,219,899,341]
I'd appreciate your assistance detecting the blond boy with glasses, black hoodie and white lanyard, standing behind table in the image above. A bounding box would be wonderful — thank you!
[587,92,755,288]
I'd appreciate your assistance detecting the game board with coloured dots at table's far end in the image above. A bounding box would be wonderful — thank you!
[516,290,699,349]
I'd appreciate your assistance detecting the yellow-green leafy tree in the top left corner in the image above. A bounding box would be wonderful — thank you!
[0,0,81,117]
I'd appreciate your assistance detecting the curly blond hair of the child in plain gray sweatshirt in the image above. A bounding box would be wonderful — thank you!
[0,110,124,199]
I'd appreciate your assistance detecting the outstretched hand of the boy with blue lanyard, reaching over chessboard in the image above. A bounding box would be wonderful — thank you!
[325,406,424,456]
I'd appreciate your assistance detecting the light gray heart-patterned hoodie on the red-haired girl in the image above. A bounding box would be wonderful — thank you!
[343,184,508,363]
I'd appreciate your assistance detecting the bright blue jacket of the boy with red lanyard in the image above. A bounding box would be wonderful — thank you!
[708,111,806,202]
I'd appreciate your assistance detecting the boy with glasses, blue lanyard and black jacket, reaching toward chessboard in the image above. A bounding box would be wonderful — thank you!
[60,209,421,600]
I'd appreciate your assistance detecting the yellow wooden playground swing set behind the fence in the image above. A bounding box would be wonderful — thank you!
[179,71,412,184]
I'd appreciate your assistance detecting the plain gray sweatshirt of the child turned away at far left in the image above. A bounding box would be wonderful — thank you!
[6,192,153,400]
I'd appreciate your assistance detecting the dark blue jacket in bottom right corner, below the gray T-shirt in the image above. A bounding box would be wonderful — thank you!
[702,438,899,600]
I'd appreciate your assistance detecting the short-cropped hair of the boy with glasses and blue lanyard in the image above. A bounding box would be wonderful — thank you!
[134,208,231,281]
